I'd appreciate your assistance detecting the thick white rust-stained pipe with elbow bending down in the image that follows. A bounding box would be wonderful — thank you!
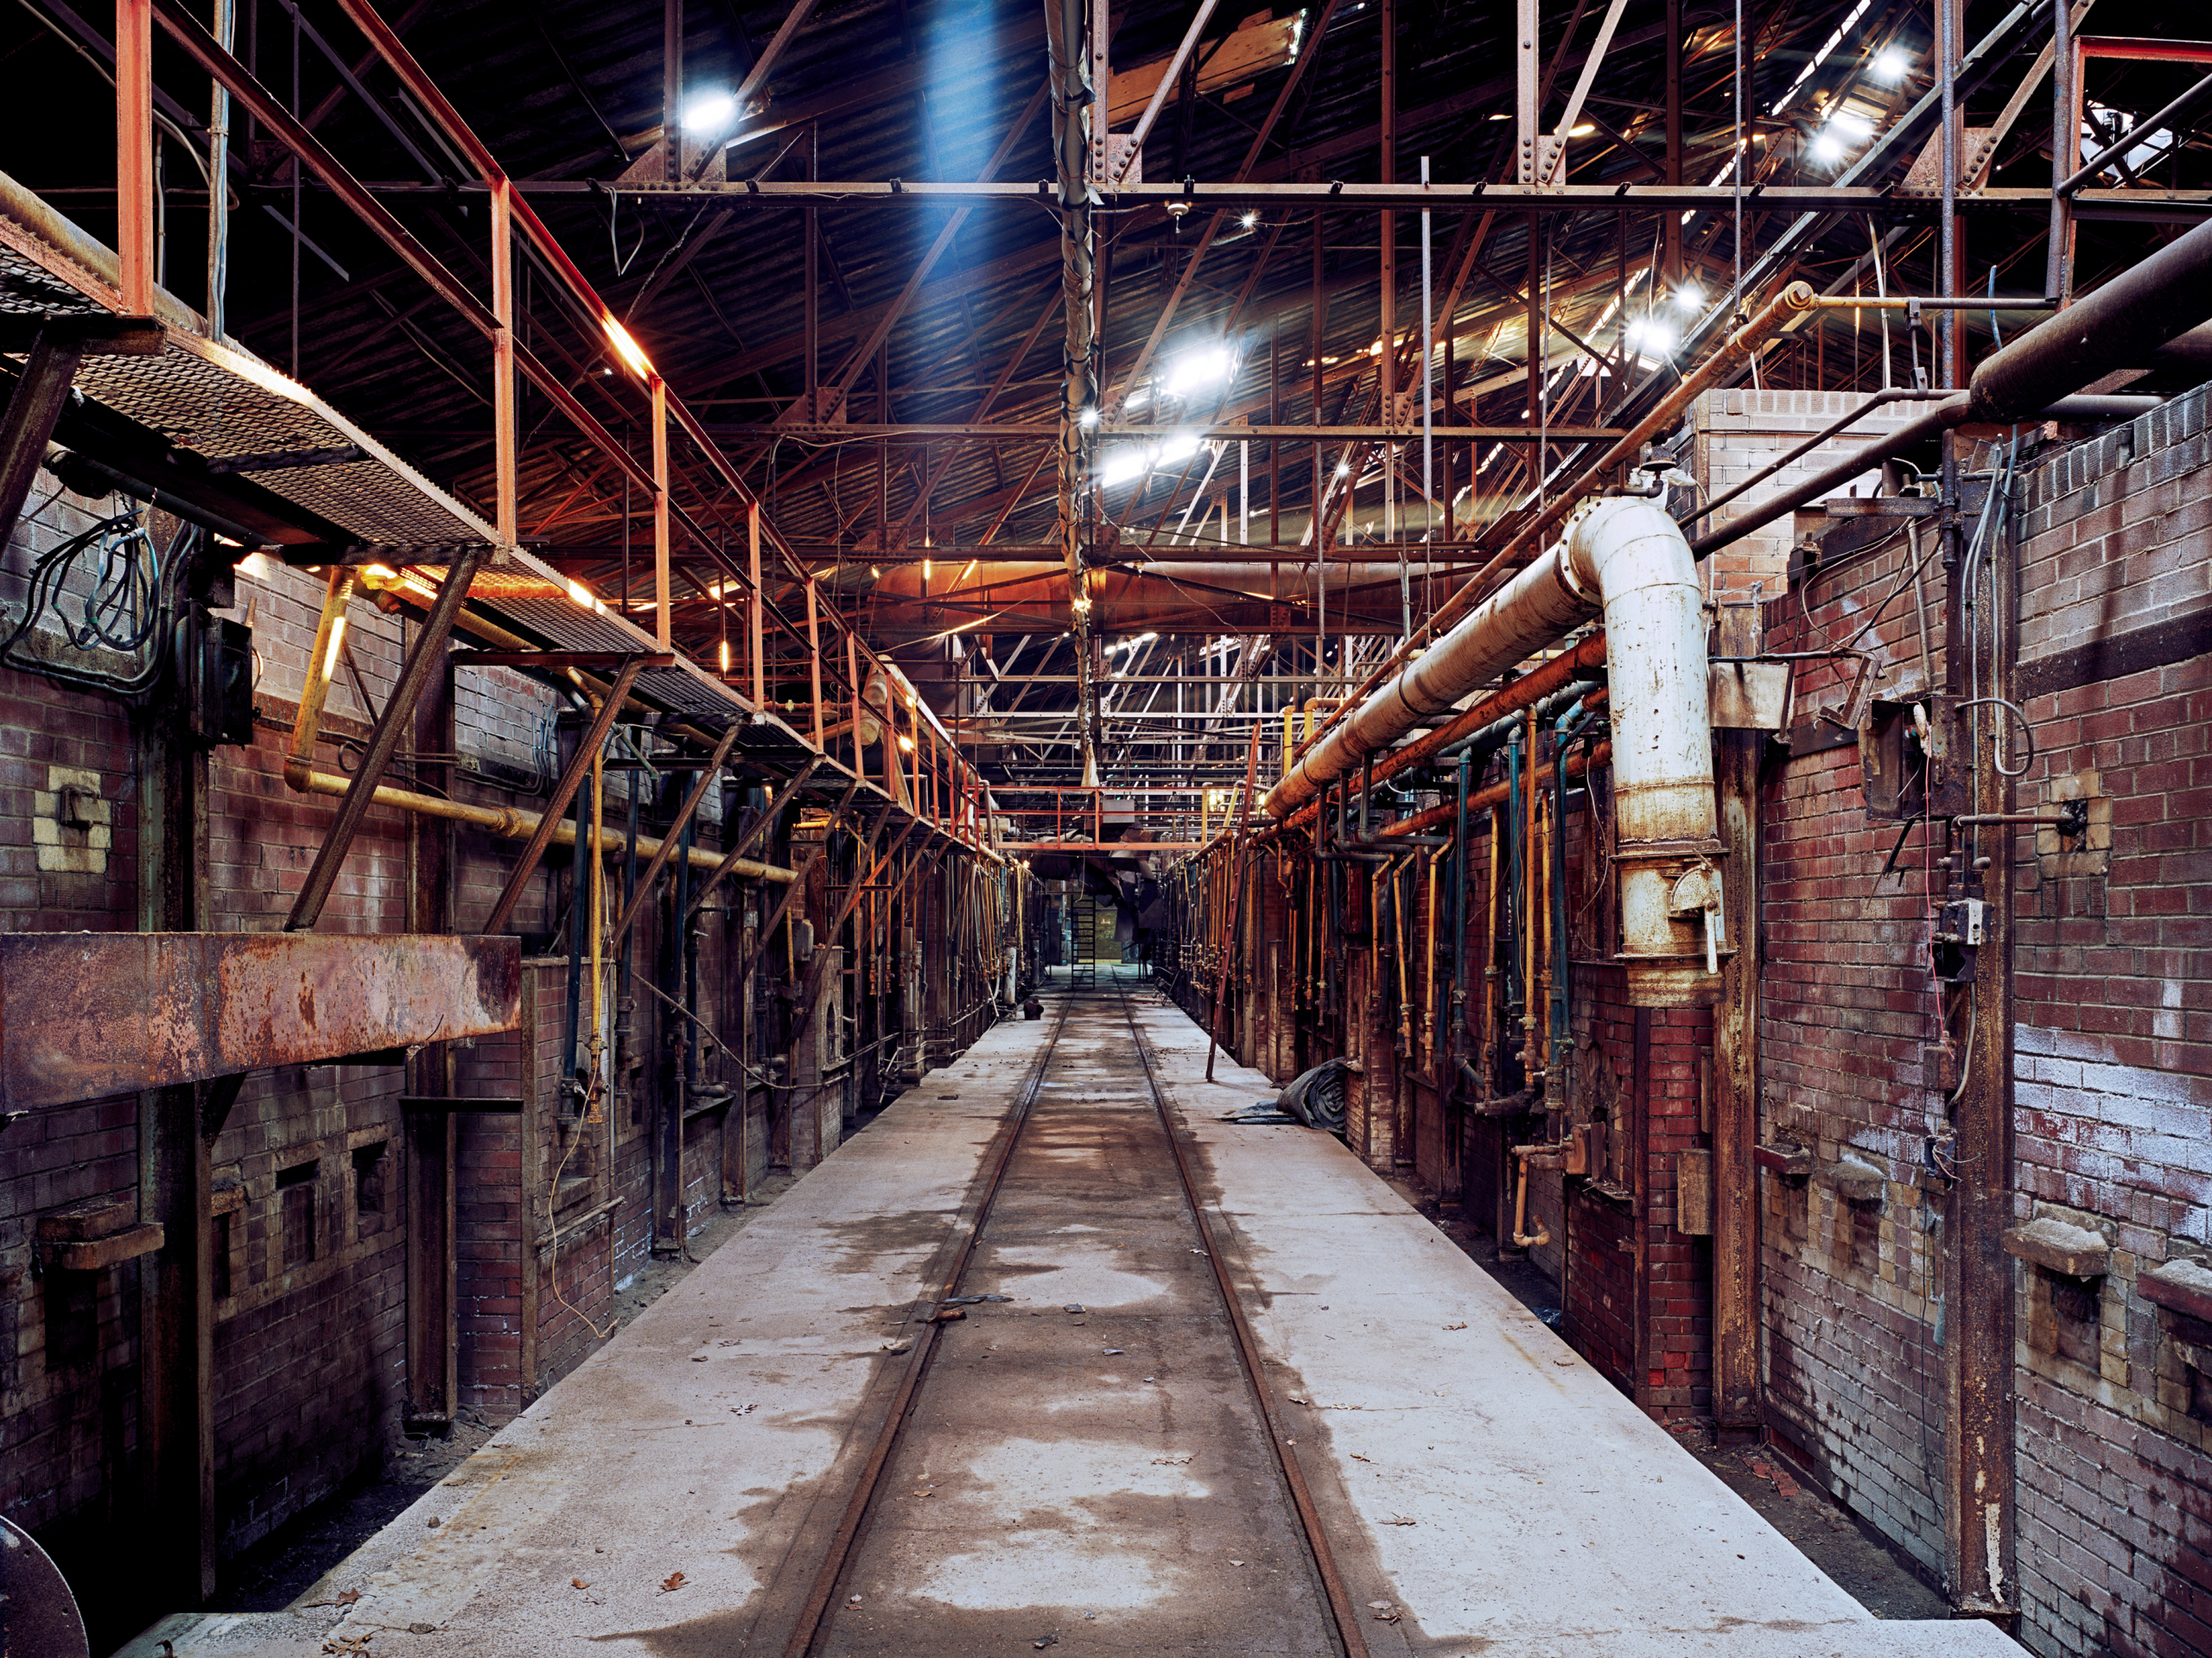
[1265,495,1721,1006]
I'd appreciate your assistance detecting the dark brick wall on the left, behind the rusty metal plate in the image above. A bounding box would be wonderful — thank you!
[0,484,583,1563]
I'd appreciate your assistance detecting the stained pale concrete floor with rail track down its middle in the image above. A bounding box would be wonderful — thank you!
[126,981,2011,1658]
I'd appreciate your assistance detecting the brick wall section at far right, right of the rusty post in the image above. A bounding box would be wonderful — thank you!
[2011,389,2212,1655]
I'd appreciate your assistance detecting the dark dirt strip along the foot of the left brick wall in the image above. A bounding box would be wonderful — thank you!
[210,1166,814,1611]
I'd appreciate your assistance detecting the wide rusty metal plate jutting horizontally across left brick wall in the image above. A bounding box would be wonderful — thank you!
[0,933,522,1109]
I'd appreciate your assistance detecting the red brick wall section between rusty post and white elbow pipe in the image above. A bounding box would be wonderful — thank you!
[1758,521,1944,1572]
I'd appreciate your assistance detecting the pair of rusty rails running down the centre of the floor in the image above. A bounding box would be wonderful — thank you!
[783,981,1367,1658]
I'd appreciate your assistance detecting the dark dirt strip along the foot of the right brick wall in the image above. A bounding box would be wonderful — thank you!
[1389,1178,1951,1618]
